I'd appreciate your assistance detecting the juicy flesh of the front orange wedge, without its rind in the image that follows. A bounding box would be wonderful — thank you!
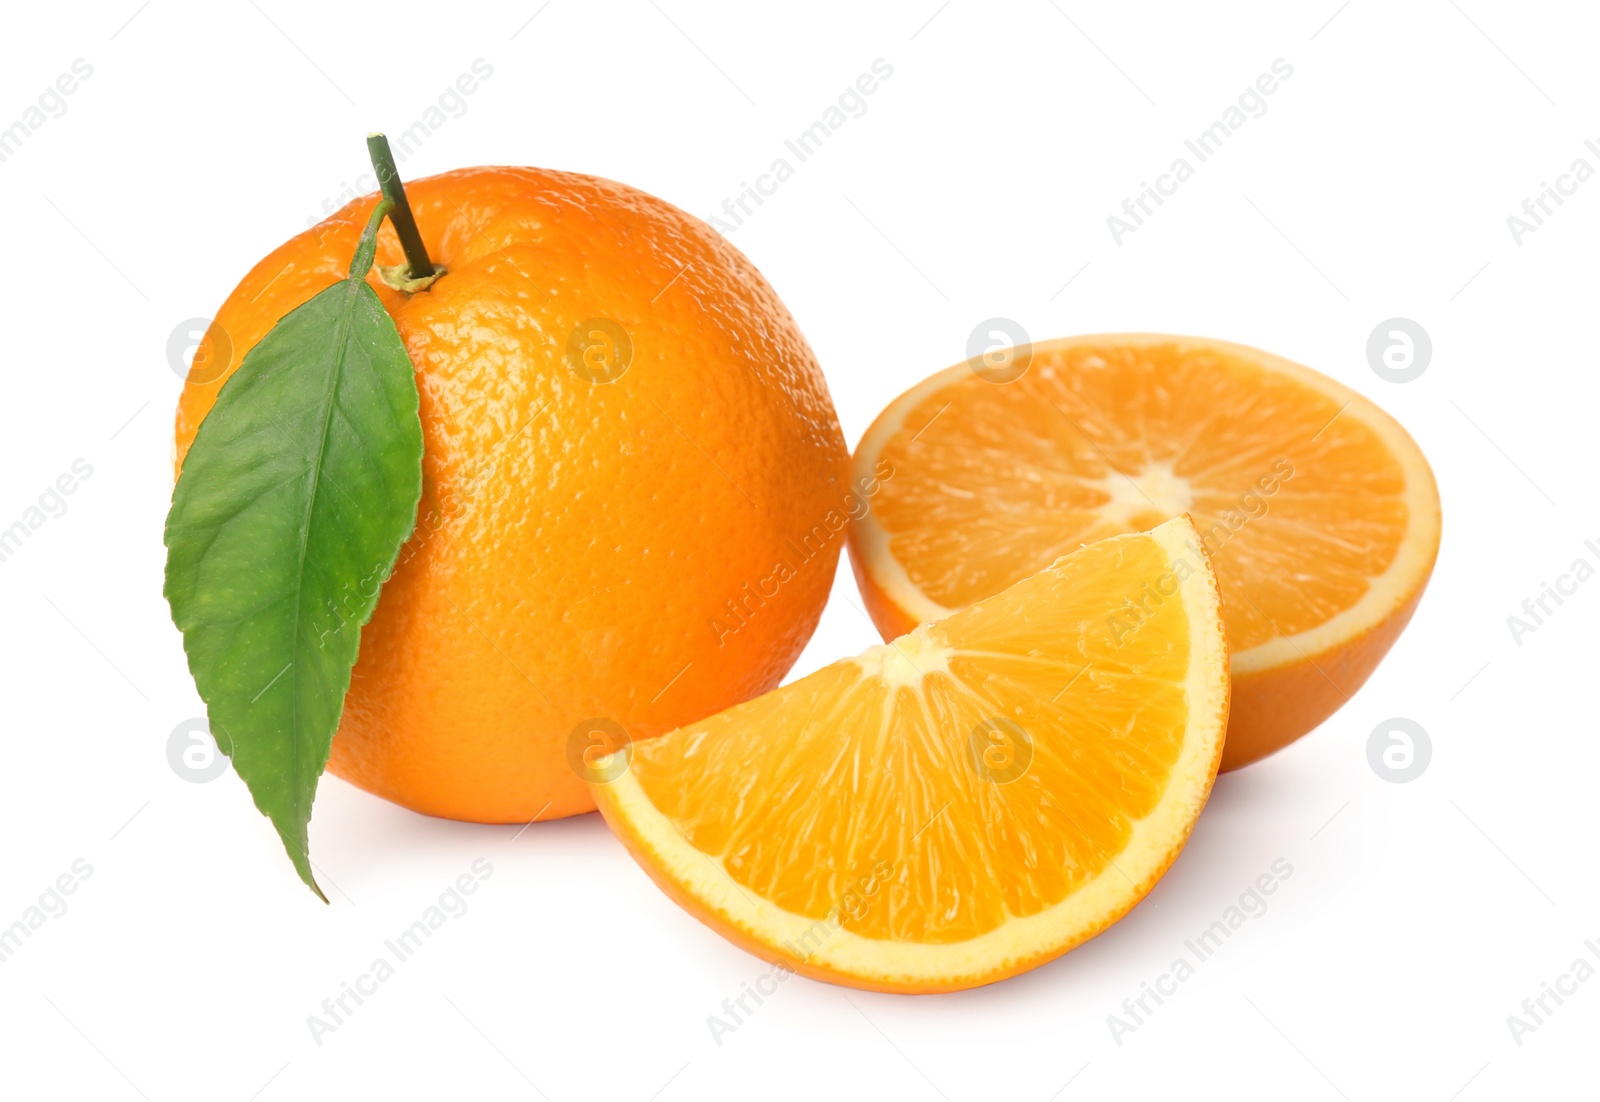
[630,527,1190,944]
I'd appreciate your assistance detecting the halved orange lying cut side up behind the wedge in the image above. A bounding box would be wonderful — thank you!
[850,334,1440,769]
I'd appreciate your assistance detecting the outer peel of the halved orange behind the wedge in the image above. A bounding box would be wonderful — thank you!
[850,521,1432,773]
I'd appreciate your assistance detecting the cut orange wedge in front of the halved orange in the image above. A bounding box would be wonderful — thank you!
[587,518,1229,992]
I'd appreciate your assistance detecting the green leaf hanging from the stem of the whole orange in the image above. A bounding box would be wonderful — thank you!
[166,202,422,902]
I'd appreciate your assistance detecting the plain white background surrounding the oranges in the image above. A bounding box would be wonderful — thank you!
[0,0,1600,1102]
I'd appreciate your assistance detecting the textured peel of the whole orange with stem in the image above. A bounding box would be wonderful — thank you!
[176,168,848,822]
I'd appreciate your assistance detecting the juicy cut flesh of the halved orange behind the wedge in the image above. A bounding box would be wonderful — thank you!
[874,344,1408,653]
